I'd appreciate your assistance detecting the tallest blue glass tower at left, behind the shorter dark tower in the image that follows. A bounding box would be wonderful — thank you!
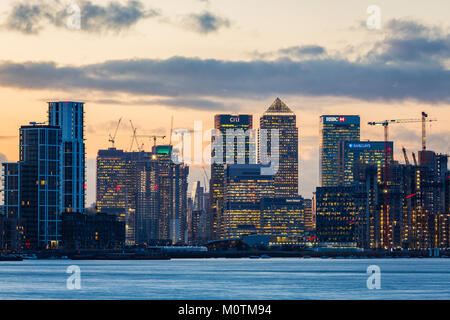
[48,101,86,213]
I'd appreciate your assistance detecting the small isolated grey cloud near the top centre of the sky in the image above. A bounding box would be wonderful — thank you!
[182,11,231,34]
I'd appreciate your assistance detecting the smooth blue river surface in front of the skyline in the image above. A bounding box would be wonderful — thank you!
[0,258,450,300]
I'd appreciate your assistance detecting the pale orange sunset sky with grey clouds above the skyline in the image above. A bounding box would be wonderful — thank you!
[0,0,450,204]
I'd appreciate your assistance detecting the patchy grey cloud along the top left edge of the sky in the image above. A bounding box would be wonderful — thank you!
[3,0,160,35]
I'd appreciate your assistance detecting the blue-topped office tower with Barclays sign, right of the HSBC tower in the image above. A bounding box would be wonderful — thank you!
[338,141,394,186]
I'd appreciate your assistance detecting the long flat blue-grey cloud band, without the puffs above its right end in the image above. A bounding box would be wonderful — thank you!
[0,53,450,105]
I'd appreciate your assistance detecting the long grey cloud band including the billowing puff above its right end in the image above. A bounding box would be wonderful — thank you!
[0,21,450,110]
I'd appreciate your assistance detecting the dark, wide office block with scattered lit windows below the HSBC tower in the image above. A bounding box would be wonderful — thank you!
[315,186,367,247]
